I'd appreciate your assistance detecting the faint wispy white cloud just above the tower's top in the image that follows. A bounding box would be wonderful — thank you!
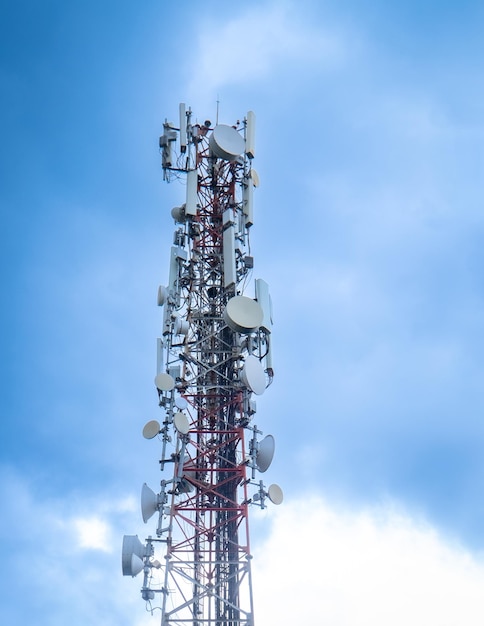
[184,2,347,104]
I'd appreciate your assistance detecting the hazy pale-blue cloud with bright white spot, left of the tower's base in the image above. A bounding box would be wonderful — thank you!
[0,467,147,626]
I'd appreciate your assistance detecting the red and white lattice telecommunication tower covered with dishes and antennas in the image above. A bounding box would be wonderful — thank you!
[122,104,283,626]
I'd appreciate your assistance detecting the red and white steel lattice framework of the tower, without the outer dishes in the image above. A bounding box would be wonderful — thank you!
[162,129,253,626]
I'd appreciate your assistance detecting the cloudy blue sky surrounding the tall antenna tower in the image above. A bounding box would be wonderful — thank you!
[0,0,484,626]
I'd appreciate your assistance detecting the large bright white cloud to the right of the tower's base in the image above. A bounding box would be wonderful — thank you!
[253,498,484,626]
